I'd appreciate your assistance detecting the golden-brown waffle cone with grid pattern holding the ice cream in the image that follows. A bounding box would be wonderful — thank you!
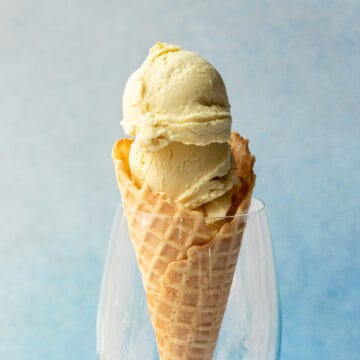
[112,133,255,360]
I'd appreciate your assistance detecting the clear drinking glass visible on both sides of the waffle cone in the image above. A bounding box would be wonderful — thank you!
[97,198,281,360]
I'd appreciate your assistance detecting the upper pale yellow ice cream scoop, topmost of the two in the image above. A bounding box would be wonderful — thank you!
[122,43,231,150]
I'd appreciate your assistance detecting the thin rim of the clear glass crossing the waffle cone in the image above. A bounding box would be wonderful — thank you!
[119,196,265,221]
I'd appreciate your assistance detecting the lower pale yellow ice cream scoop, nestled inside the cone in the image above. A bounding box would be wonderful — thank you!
[129,141,236,209]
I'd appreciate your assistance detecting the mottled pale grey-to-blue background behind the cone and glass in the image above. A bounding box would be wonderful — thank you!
[0,0,360,360]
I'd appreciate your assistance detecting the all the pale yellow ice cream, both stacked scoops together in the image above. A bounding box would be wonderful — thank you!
[122,43,239,222]
